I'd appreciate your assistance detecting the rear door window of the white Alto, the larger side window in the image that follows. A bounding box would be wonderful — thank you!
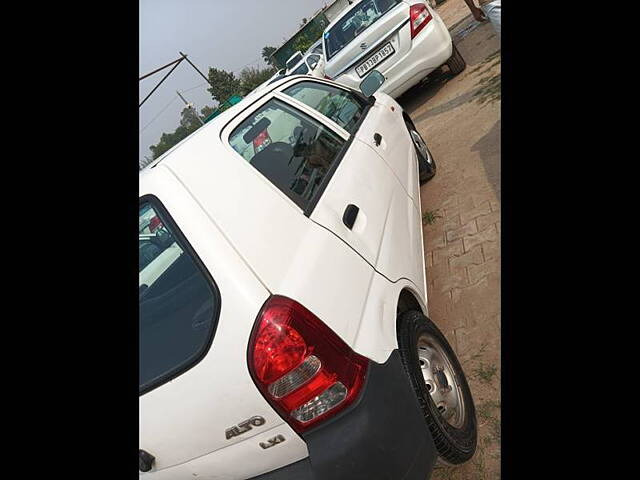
[229,99,345,210]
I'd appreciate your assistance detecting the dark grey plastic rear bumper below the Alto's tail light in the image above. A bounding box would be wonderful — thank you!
[252,350,437,480]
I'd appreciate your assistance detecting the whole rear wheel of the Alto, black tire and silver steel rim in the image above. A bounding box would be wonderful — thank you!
[398,311,478,465]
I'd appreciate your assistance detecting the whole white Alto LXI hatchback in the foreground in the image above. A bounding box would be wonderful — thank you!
[139,71,476,480]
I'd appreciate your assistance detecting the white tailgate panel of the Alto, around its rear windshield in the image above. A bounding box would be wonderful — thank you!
[139,169,308,479]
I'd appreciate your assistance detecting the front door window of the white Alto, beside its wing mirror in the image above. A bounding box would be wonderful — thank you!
[284,82,365,133]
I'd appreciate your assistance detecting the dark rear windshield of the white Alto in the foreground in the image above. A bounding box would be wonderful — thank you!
[138,201,220,393]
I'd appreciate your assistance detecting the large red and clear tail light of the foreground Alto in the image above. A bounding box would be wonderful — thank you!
[248,295,369,433]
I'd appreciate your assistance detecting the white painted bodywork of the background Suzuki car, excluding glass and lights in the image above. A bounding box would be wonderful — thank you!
[324,0,453,98]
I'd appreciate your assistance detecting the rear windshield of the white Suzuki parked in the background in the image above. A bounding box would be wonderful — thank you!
[324,0,400,60]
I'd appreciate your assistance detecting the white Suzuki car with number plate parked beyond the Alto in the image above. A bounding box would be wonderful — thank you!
[323,0,466,98]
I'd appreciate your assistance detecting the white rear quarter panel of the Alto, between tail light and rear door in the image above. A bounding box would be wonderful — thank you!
[166,116,374,358]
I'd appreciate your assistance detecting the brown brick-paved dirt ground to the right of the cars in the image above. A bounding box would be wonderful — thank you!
[398,0,501,480]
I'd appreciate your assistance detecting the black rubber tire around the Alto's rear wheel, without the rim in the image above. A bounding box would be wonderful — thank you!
[398,311,478,465]
